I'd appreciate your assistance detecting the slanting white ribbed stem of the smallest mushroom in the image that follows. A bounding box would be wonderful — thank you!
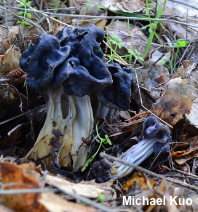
[111,138,156,177]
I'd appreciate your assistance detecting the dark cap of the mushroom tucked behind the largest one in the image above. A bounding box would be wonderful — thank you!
[98,62,134,110]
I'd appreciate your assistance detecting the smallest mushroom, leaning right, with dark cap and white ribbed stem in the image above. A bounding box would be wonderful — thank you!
[111,116,172,177]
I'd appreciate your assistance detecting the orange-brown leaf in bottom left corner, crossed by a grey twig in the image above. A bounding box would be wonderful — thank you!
[1,162,47,212]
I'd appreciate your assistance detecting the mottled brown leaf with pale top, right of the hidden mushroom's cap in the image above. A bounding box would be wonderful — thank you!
[153,77,197,126]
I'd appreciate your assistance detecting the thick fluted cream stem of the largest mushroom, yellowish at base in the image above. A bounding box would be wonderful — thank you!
[32,85,94,169]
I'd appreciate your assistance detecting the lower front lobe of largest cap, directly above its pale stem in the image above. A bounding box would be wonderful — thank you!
[54,57,111,96]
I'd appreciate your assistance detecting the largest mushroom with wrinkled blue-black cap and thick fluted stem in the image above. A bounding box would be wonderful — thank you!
[20,25,135,169]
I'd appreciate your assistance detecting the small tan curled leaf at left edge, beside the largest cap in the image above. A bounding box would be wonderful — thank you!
[0,45,21,74]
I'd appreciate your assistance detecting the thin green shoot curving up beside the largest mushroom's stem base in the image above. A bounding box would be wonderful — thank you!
[81,123,112,172]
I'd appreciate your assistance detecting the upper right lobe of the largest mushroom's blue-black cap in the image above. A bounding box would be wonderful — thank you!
[57,24,107,82]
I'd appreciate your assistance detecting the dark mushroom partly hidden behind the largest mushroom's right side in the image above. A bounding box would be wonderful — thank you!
[93,61,134,122]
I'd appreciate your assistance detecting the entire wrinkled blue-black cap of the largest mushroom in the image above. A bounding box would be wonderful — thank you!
[20,25,113,96]
